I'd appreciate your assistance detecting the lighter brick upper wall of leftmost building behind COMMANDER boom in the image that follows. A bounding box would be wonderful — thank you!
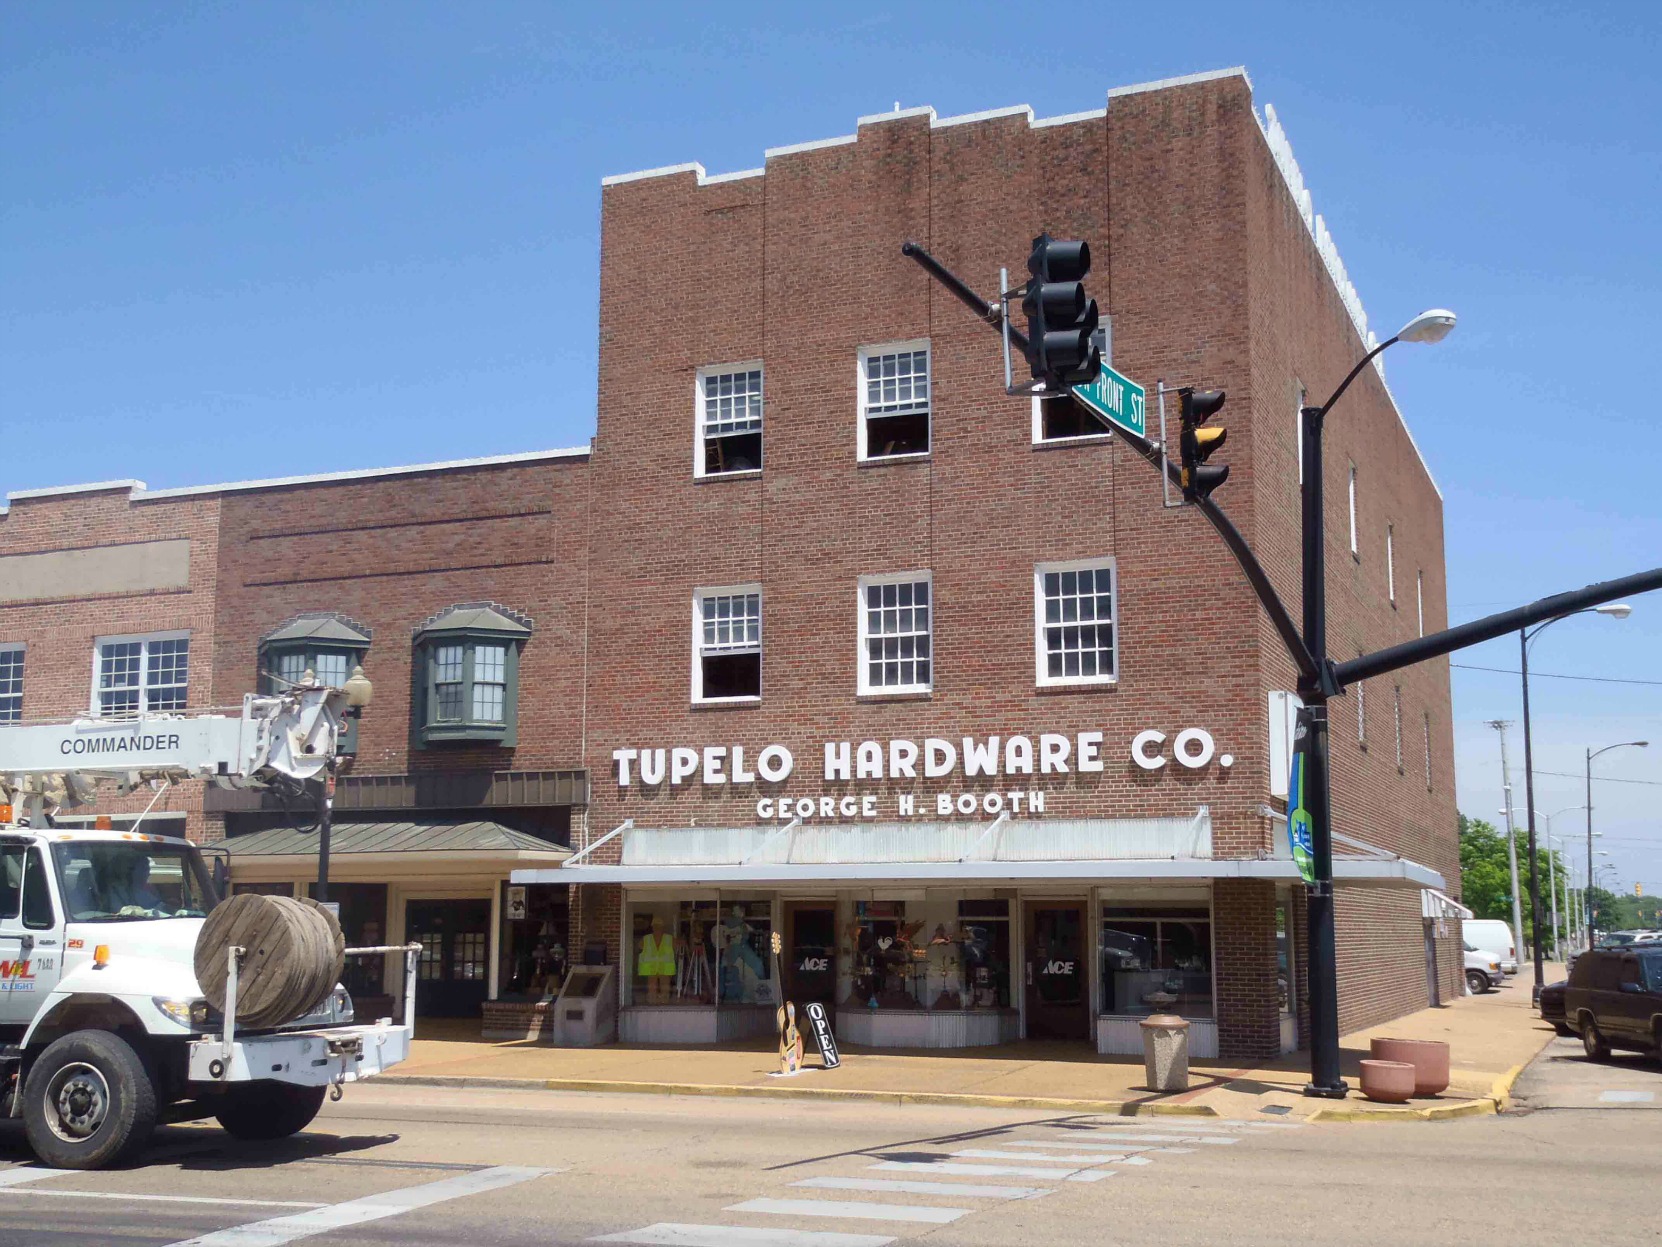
[0,485,223,836]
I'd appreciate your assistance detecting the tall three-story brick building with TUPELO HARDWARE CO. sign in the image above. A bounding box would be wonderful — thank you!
[524,71,1461,1057]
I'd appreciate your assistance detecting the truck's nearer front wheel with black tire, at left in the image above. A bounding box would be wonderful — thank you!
[23,1031,156,1169]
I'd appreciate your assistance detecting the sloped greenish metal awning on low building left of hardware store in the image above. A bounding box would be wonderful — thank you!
[221,820,572,865]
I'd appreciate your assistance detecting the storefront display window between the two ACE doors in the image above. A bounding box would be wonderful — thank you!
[846,898,1010,1009]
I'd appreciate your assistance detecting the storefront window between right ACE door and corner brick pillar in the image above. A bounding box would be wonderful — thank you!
[1102,909,1213,1018]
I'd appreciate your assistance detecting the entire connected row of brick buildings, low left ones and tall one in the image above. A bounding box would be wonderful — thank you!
[0,71,1461,1057]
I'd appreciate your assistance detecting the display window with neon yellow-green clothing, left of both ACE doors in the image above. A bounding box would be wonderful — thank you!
[628,896,778,1006]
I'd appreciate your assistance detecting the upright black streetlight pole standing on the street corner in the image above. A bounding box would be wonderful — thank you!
[1298,405,1355,1099]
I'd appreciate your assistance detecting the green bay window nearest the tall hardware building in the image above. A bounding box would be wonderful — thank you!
[412,602,532,748]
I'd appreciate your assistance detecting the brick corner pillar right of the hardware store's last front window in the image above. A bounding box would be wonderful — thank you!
[1212,880,1281,1061]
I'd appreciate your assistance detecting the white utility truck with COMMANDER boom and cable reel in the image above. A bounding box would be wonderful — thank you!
[0,673,417,1169]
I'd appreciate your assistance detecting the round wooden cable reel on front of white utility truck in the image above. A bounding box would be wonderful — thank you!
[194,893,346,1029]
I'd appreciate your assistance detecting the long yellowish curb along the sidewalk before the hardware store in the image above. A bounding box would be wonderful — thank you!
[376,1074,1218,1117]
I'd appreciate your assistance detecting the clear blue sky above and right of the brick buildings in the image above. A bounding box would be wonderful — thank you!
[0,0,1662,911]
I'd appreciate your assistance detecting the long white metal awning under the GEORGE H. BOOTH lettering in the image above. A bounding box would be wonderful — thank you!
[512,806,1444,888]
